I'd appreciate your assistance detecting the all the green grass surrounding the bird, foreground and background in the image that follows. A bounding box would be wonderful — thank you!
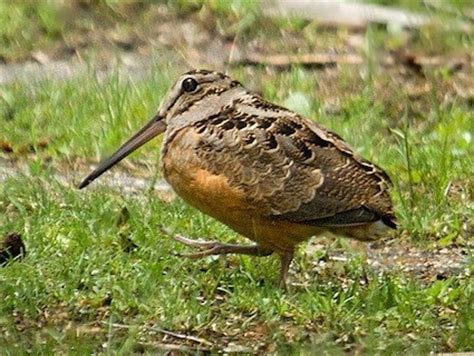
[0,1,474,354]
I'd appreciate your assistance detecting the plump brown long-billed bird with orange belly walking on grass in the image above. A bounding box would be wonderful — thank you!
[79,69,397,288]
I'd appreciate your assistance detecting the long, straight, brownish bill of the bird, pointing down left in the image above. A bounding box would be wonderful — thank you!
[79,115,166,189]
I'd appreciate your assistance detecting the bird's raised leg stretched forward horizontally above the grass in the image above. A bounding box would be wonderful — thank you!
[161,227,273,258]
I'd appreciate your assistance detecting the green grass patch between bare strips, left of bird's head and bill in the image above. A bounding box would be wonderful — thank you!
[2,66,176,160]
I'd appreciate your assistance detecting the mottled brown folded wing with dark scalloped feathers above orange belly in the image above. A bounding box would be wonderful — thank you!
[196,95,395,226]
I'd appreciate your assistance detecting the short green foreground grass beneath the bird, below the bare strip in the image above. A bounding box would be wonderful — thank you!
[0,171,474,353]
